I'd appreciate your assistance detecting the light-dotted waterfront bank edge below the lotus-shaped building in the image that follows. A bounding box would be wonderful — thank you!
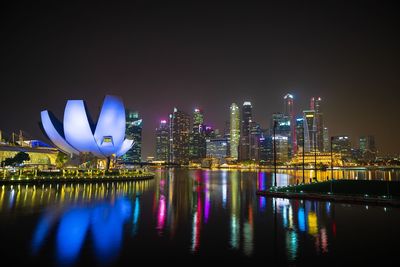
[0,173,154,185]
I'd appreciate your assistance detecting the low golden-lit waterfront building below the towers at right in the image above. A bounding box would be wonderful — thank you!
[290,152,343,167]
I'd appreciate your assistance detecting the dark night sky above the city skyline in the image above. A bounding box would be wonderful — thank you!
[0,0,400,157]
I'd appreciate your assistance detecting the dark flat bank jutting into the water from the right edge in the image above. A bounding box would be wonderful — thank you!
[257,180,400,206]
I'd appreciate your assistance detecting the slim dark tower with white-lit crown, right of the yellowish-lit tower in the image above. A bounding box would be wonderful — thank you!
[239,101,253,160]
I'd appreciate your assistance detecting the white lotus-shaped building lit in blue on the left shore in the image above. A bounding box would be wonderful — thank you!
[41,95,133,158]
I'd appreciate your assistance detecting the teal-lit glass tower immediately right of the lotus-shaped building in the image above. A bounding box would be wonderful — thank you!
[122,109,143,163]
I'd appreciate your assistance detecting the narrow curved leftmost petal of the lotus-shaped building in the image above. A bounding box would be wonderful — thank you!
[40,110,79,155]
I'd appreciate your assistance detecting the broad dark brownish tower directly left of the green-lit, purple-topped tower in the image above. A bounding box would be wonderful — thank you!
[170,108,190,164]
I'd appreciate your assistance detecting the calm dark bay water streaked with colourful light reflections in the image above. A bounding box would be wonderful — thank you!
[0,169,400,266]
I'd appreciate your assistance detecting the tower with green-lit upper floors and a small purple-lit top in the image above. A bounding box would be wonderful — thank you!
[189,108,206,160]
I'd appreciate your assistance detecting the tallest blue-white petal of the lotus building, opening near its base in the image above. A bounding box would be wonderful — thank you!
[94,95,126,156]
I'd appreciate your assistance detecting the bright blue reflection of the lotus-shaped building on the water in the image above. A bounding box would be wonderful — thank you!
[31,198,131,265]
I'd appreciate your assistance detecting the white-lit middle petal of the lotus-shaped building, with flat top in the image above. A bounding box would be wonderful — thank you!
[64,100,104,157]
